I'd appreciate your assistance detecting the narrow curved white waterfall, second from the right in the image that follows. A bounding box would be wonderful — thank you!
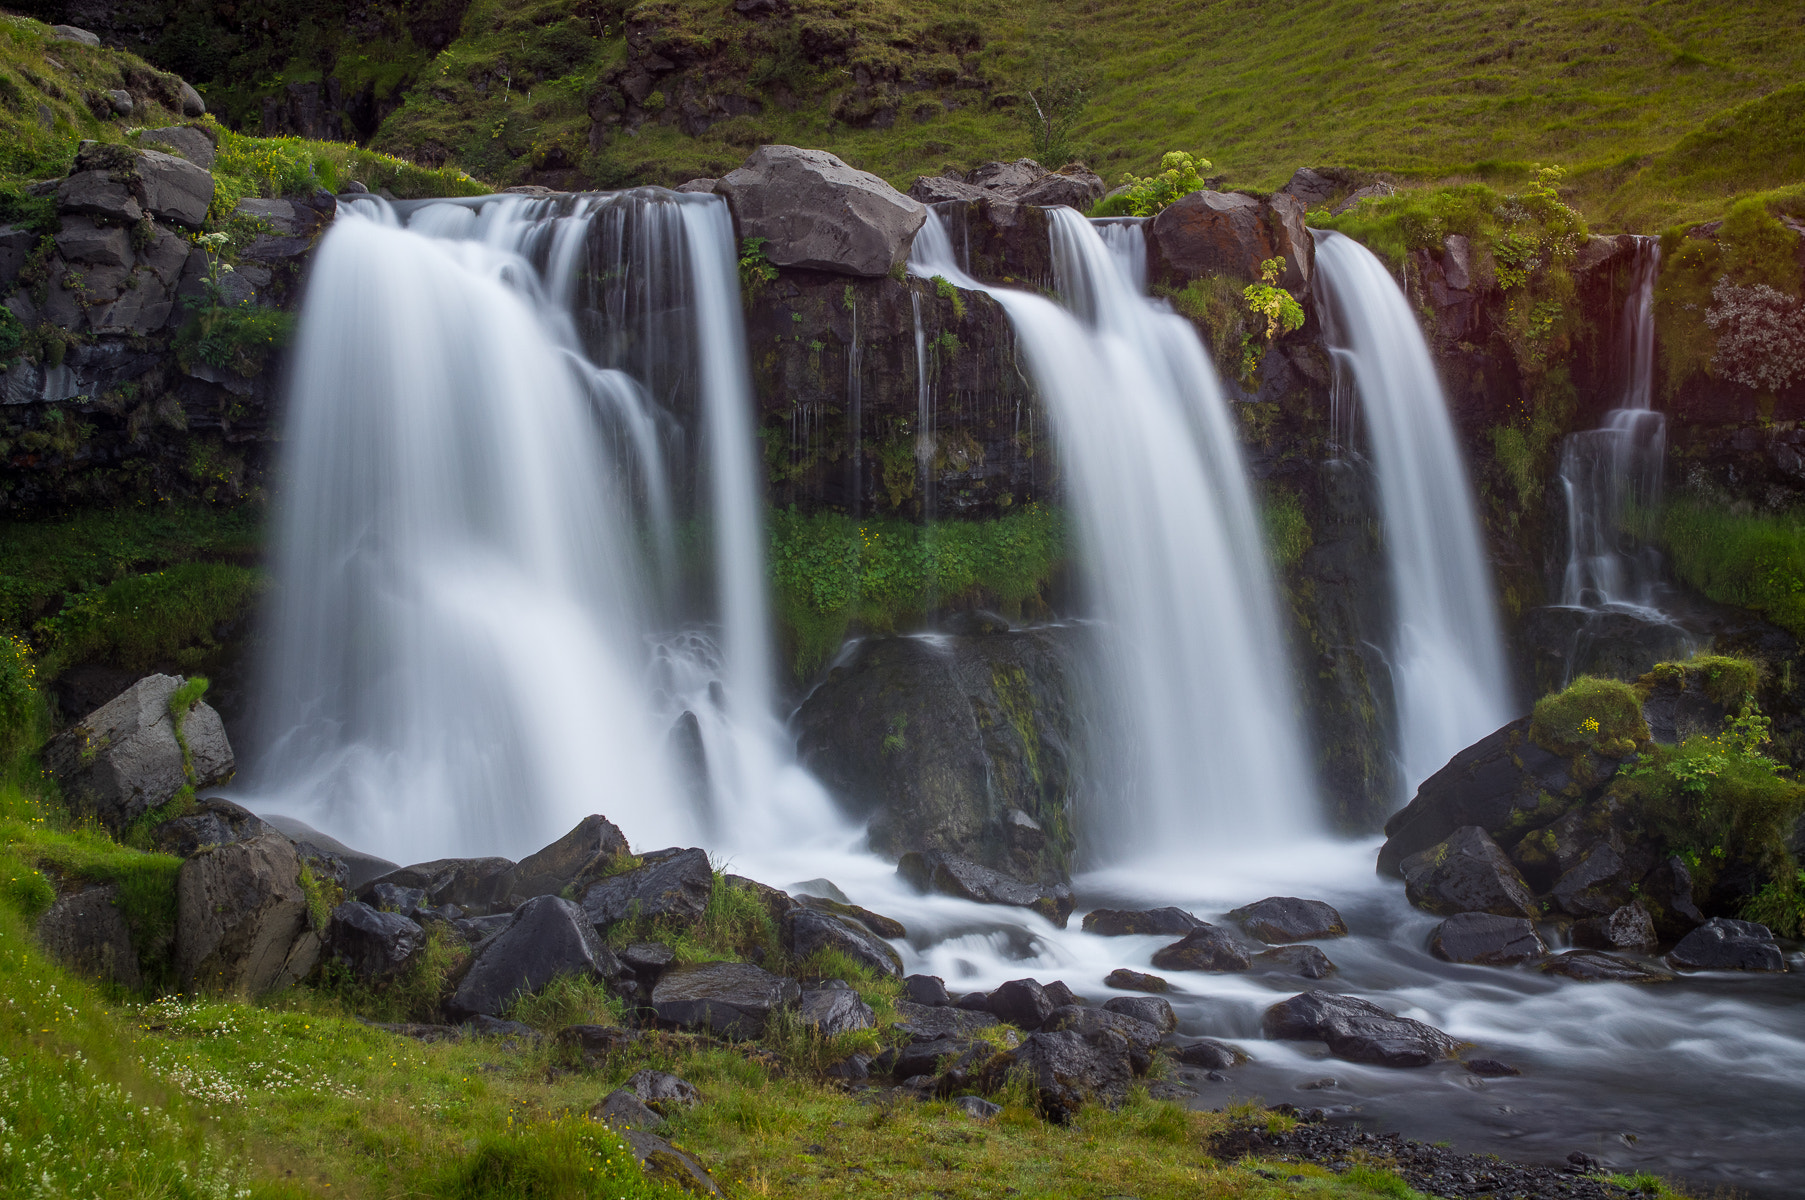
[1316,233,1513,792]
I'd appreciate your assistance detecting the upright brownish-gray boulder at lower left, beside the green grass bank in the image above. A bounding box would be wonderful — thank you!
[175,834,319,996]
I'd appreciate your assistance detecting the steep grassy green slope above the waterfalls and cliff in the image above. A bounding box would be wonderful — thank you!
[17,0,1805,229]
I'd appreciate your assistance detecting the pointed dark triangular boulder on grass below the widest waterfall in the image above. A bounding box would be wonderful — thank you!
[448,895,621,1016]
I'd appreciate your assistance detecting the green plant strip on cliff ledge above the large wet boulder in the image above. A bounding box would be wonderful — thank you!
[771,501,1065,675]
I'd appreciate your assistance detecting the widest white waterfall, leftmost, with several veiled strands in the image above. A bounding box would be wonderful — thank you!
[249,189,834,861]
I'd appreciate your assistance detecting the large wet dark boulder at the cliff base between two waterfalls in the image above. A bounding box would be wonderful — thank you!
[796,627,1081,882]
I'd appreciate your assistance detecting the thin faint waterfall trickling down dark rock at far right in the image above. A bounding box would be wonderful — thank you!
[1560,238,1666,619]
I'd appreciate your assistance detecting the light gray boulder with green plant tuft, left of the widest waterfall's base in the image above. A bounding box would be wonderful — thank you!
[43,675,236,834]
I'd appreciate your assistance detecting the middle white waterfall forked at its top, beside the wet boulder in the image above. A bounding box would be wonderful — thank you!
[910,208,1318,861]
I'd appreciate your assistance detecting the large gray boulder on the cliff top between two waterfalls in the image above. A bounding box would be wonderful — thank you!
[715,146,928,276]
